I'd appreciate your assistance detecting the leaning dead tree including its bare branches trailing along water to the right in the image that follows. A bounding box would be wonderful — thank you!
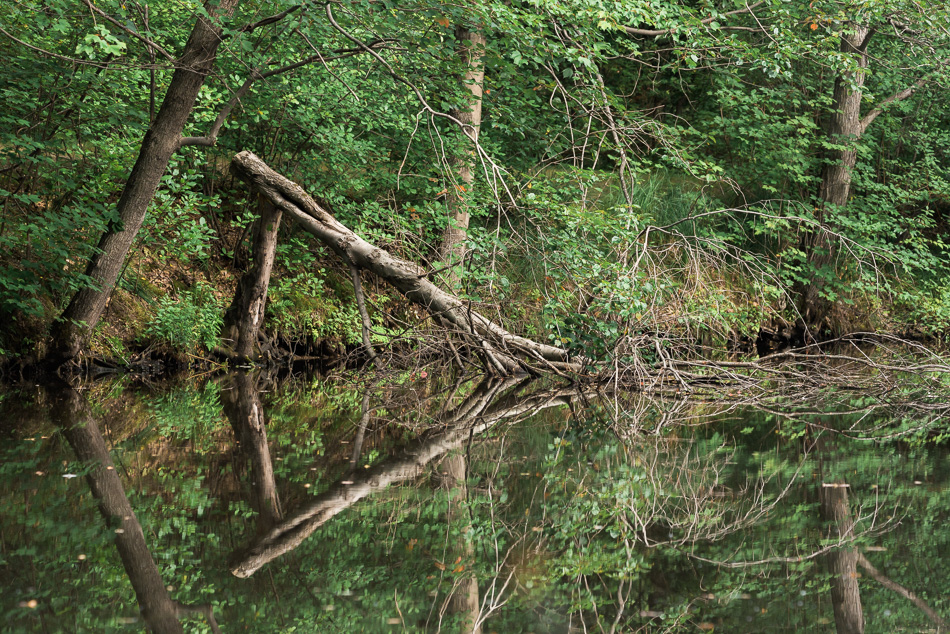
[231,152,950,392]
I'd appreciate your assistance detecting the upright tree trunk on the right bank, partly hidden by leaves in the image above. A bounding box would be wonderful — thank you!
[801,26,870,332]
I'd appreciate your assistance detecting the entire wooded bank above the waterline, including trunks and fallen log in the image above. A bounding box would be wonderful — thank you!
[0,0,950,390]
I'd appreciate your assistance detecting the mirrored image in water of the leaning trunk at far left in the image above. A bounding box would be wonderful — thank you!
[50,386,219,634]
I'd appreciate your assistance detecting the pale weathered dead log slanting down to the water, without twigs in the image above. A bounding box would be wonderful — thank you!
[231,151,585,374]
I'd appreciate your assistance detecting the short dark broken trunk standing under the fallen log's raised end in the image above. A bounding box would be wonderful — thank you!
[224,197,283,359]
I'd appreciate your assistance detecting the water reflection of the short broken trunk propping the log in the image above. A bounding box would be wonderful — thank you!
[221,372,281,533]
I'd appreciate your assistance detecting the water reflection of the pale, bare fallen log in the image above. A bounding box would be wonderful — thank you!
[231,378,581,577]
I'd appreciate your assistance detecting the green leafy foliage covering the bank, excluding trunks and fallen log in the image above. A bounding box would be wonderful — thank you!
[0,0,950,362]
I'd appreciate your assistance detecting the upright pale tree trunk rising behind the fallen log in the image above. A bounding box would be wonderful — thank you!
[442,26,486,286]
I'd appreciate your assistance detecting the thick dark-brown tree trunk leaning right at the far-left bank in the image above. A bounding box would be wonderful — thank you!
[47,0,241,365]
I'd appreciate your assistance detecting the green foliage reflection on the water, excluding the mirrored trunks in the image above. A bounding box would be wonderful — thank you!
[0,372,950,632]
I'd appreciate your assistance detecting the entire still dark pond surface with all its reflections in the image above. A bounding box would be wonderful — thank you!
[0,368,950,633]
